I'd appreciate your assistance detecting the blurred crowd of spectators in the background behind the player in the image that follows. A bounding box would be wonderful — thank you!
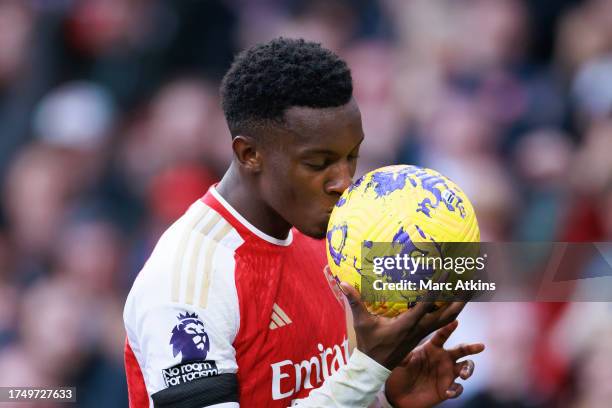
[0,0,612,408]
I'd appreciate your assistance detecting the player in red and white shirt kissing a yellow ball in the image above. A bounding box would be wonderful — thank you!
[124,38,484,408]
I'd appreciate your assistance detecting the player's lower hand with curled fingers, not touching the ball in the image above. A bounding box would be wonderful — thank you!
[385,320,485,408]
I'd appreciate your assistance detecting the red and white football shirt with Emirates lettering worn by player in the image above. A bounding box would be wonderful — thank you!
[124,187,354,408]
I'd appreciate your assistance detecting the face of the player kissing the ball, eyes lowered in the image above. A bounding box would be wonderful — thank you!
[260,100,363,238]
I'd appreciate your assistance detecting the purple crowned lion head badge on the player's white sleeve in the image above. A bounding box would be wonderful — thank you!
[170,313,210,363]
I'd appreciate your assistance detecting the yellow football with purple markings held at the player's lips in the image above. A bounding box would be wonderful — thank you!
[326,165,480,317]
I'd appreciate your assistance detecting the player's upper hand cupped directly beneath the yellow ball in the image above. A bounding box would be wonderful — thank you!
[340,282,465,370]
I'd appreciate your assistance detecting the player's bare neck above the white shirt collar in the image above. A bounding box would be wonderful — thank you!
[216,163,291,240]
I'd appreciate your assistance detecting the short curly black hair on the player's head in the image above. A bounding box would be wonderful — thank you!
[221,37,353,136]
